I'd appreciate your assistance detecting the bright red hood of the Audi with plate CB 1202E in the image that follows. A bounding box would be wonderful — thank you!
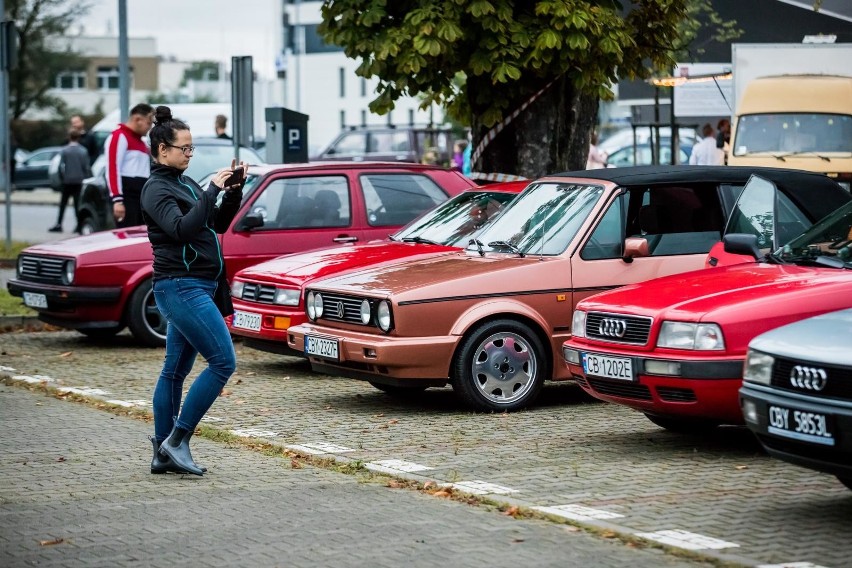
[580,264,852,325]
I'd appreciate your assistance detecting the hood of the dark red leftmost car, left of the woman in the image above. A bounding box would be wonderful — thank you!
[20,226,152,262]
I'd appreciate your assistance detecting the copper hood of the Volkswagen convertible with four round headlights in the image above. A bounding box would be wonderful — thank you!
[310,251,569,302]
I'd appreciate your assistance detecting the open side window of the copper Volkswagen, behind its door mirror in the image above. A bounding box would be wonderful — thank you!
[626,185,724,256]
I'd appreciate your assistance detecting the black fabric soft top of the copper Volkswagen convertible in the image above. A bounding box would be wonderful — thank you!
[546,165,842,189]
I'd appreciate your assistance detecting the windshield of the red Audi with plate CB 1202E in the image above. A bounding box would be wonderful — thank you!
[775,202,852,268]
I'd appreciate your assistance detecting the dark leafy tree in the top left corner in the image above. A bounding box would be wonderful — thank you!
[5,0,89,119]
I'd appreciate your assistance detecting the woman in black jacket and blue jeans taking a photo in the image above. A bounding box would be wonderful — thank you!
[142,106,246,475]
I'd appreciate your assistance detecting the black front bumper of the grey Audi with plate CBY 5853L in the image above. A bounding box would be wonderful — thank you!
[740,383,852,478]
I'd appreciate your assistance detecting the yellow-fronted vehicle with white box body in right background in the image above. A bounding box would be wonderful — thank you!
[728,43,852,187]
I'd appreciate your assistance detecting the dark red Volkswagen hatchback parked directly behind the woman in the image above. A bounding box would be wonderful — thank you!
[7,162,474,346]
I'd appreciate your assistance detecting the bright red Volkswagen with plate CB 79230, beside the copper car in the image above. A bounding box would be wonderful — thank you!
[228,181,529,356]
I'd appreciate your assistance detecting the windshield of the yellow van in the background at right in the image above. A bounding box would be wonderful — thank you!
[734,113,852,156]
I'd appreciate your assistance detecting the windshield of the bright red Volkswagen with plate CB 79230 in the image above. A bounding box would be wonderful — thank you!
[393,191,517,246]
